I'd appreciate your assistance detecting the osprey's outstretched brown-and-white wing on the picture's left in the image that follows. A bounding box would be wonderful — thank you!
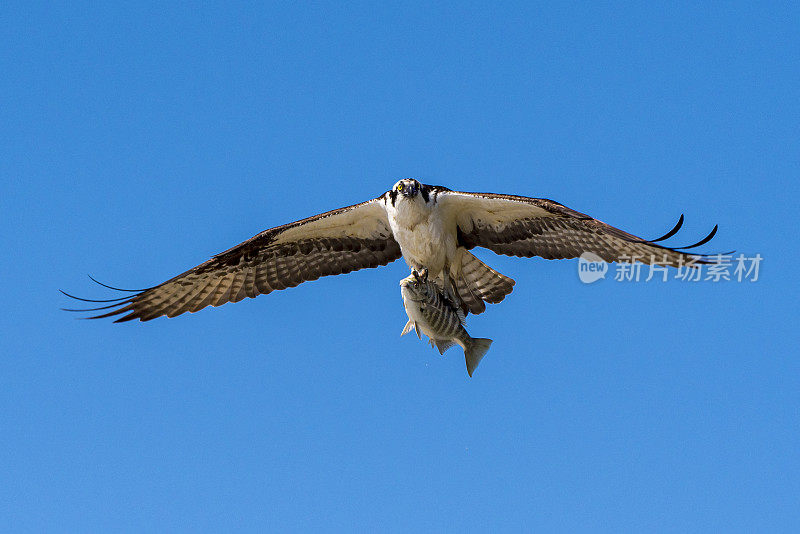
[69,197,401,322]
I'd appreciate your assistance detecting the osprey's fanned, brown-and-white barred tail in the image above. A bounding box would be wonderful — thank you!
[453,249,515,314]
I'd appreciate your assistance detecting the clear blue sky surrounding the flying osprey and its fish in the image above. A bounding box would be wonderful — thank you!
[0,2,800,532]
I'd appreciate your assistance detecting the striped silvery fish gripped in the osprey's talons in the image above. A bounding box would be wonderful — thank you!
[400,270,492,376]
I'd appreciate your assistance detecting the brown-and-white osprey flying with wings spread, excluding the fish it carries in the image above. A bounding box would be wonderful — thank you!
[61,179,716,322]
